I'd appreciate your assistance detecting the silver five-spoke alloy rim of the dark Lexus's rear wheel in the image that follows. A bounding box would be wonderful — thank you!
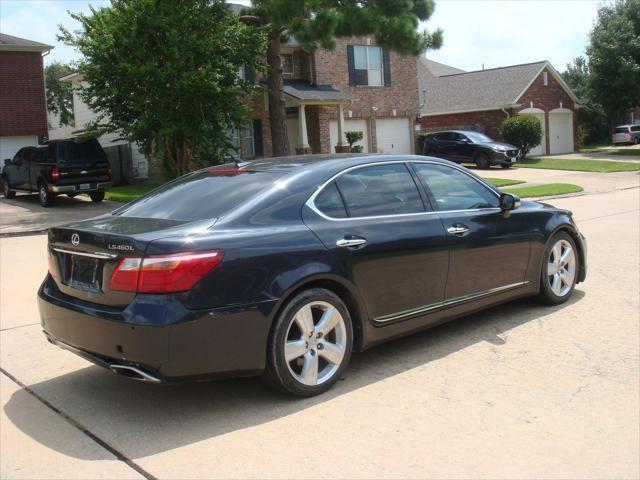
[284,301,348,386]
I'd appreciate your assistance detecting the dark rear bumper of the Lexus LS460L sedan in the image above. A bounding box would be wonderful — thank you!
[38,276,276,383]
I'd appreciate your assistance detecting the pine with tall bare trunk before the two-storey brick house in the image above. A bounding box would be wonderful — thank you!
[242,0,442,155]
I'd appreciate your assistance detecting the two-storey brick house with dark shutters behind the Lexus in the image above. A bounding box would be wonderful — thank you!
[241,37,418,158]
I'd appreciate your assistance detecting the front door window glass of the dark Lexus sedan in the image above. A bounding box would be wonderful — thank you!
[414,163,500,211]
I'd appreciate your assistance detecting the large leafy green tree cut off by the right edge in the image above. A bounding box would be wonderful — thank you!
[587,0,640,127]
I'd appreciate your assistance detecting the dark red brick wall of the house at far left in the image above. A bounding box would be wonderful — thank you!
[0,52,48,139]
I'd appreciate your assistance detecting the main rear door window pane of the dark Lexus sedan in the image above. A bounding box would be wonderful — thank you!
[336,163,424,217]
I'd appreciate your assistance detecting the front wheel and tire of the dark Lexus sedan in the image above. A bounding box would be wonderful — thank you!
[538,232,580,305]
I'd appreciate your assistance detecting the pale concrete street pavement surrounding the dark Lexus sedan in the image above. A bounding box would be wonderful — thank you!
[0,172,640,479]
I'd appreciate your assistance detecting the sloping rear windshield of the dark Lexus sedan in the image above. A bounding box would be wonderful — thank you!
[119,168,283,221]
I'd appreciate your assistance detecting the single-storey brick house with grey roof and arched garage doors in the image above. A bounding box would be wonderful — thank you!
[418,57,579,155]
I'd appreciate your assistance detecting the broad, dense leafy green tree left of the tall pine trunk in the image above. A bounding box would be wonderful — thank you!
[60,0,265,175]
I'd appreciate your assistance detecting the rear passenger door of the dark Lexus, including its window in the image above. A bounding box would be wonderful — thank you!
[303,163,449,322]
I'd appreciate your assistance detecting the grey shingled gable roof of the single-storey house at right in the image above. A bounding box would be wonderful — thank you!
[419,60,579,115]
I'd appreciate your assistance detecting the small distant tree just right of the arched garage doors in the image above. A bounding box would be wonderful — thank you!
[562,57,609,143]
